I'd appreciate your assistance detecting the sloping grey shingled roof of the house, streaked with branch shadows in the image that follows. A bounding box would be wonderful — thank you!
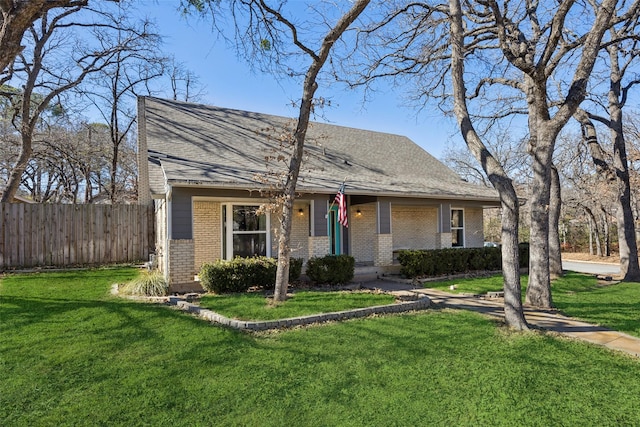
[140,97,498,203]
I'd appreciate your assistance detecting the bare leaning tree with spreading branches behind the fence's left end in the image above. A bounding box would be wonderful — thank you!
[0,2,158,202]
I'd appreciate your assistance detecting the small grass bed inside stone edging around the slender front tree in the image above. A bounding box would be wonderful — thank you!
[200,291,394,320]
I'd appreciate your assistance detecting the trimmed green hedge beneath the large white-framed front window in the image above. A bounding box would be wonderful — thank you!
[199,257,302,294]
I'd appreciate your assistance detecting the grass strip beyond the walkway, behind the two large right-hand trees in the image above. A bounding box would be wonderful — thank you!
[425,272,640,337]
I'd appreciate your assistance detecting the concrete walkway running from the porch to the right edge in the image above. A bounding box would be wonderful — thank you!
[362,280,640,357]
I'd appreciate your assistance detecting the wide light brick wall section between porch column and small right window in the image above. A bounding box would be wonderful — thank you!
[391,205,438,249]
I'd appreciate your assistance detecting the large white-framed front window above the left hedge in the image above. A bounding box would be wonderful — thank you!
[222,205,271,259]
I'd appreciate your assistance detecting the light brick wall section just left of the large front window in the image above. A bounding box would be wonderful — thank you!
[193,200,222,271]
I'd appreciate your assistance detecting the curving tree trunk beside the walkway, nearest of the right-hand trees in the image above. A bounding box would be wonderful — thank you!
[449,0,529,330]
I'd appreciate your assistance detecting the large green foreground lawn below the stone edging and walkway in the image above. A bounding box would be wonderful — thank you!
[0,269,640,426]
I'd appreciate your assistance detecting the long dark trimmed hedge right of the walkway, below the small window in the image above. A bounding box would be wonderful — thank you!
[398,243,529,277]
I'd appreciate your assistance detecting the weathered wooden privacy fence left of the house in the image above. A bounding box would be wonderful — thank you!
[0,203,155,269]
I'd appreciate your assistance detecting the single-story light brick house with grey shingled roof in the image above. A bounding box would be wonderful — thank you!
[138,97,499,289]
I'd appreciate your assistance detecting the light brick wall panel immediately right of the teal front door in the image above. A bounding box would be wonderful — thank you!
[349,204,377,262]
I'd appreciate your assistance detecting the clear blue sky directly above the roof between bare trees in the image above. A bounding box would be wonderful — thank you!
[138,0,462,158]
